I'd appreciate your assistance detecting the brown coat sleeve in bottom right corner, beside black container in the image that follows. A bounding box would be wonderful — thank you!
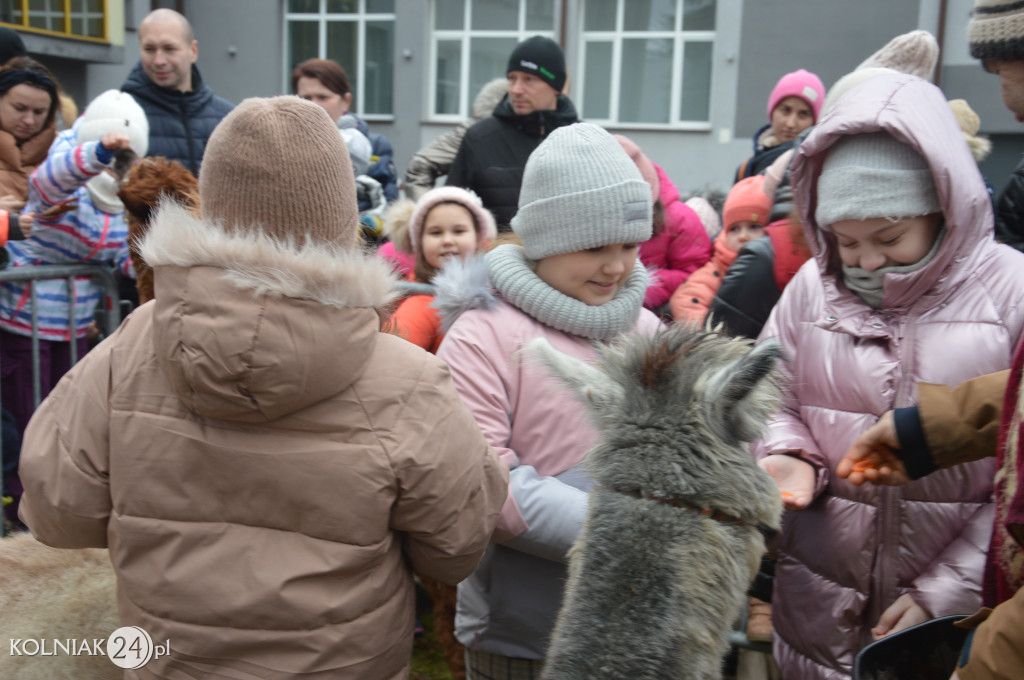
[956,590,1024,680]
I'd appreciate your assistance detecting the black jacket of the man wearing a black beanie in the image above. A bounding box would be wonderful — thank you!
[445,95,580,231]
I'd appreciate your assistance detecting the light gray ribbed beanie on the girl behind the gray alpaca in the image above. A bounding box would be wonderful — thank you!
[512,123,652,260]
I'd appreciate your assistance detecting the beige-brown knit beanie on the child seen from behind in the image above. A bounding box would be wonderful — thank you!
[199,96,359,247]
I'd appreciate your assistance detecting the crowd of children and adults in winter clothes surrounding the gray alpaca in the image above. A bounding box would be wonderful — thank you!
[0,0,1024,680]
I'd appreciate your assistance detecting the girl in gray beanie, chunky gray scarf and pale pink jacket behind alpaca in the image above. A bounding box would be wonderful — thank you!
[434,123,658,678]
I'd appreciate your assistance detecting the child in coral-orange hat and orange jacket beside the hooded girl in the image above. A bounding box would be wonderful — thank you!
[669,175,771,324]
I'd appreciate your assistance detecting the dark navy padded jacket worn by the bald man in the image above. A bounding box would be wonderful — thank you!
[121,61,234,177]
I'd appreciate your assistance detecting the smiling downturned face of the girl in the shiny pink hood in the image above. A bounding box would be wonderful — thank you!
[831,213,941,271]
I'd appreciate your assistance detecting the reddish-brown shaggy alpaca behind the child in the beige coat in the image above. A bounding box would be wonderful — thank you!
[118,157,199,304]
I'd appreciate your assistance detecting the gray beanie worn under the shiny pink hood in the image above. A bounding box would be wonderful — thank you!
[814,132,942,230]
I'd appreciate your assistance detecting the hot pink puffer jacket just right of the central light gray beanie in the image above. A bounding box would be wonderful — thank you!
[640,165,712,309]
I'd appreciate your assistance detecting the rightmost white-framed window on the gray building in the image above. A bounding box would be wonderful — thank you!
[572,0,721,132]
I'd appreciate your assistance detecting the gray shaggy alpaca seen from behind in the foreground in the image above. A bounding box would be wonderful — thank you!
[529,325,782,680]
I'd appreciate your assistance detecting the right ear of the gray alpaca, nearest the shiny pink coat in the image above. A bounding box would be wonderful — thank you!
[710,338,782,441]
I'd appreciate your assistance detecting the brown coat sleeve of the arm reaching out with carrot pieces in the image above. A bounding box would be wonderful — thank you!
[918,371,1010,468]
